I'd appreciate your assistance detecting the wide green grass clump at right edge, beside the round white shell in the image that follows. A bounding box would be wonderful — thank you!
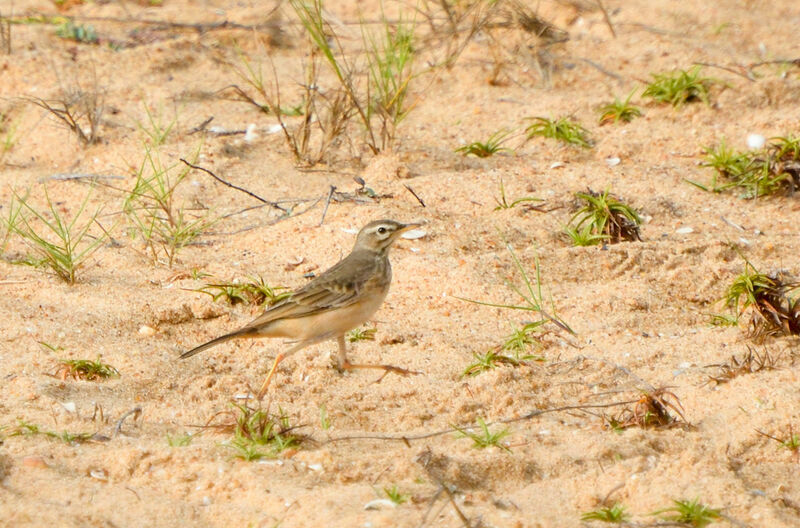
[687,135,800,199]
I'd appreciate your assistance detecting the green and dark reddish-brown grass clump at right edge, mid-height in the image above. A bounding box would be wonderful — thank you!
[722,259,800,338]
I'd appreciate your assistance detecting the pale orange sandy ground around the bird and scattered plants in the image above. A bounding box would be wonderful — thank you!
[0,0,800,527]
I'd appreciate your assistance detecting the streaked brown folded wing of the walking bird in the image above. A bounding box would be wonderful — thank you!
[238,254,375,328]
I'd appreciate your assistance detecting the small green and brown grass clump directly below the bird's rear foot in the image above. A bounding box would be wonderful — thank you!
[225,403,303,461]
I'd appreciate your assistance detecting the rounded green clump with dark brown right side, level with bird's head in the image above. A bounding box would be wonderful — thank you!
[565,190,642,246]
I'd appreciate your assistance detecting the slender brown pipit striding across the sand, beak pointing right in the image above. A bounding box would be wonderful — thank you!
[181,220,419,400]
